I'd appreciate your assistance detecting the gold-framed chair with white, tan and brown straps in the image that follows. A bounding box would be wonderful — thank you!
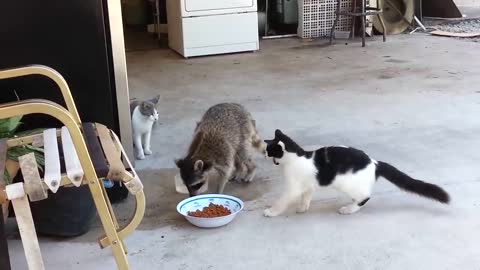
[0,65,145,270]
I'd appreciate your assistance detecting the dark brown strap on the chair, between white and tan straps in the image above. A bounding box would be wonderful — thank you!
[82,123,108,177]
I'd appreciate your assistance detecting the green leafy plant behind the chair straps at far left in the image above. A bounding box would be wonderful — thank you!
[0,116,45,184]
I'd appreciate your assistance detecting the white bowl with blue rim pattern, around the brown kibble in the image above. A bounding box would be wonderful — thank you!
[177,194,243,228]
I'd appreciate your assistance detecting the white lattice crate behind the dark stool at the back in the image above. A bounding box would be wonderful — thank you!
[297,0,352,38]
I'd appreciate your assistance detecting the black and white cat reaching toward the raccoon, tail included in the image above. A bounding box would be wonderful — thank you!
[264,129,450,217]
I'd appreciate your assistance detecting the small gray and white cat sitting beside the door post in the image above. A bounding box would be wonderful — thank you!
[130,95,160,159]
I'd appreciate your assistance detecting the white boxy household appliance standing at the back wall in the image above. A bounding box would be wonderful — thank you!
[167,0,259,57]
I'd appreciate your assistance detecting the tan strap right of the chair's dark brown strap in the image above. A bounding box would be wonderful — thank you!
[95,123,125,180]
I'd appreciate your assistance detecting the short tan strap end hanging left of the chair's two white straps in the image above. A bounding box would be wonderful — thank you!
[18,153,48,202]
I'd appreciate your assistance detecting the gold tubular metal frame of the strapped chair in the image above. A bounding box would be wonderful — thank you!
[0,65,145,270]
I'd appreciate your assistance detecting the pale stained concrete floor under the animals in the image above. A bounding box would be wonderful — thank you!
[9,34,480,270]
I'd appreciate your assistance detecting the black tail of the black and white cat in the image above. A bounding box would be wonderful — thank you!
[377,161,450,203]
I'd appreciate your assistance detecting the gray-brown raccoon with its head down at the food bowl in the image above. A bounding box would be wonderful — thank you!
[175,103,265,196]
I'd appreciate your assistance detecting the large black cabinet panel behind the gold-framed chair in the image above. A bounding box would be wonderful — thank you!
[0,0,120,135]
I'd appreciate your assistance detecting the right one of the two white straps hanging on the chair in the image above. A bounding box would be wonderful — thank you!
[61,127,84,187]
